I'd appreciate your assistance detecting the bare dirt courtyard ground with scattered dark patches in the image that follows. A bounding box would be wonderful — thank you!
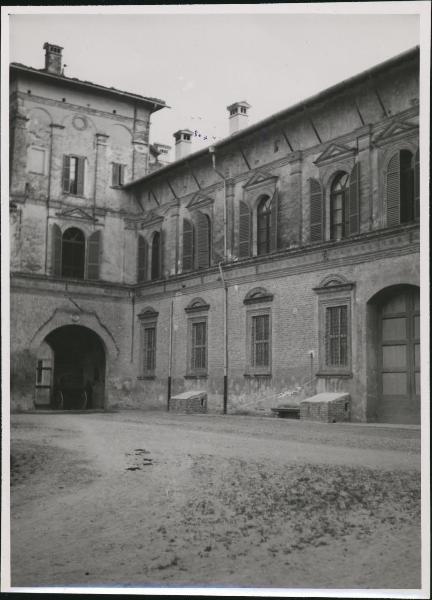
[11,411,420,589]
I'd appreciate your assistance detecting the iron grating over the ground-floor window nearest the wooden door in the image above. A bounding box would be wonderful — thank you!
[325,305,348,367]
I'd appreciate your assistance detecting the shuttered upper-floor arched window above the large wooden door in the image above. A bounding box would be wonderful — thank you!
[387,150,420,227]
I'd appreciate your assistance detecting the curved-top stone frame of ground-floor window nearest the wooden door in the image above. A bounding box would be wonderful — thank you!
[314,275,355,377]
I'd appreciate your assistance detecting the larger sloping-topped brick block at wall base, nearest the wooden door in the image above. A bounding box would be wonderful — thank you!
[300,392,351,423]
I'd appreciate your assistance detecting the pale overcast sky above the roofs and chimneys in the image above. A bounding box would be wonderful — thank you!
[10,9,419,159]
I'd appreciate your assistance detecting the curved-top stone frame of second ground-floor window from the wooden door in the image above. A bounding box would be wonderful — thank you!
[243,288,273,377]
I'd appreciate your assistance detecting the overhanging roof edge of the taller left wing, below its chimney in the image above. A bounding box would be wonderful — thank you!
[10,63,170,112]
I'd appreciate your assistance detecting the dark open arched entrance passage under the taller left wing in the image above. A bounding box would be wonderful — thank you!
[36,325,105,410]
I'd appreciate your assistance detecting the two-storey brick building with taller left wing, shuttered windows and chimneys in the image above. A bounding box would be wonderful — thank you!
[10,45,420,423]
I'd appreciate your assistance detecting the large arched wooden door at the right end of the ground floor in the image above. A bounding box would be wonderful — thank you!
[368,285,420,423]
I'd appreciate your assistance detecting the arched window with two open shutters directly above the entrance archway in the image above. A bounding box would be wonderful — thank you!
[51,224,102,280]
